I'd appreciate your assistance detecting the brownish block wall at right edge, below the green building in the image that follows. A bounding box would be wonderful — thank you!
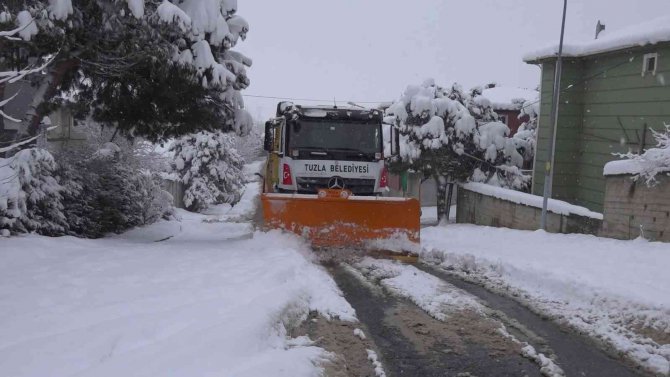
[601,175,670,242]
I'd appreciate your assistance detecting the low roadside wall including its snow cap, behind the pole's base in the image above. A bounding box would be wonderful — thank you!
[456,183,603,235]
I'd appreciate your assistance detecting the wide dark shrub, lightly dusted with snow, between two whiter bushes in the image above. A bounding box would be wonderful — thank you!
[58,143,174,238]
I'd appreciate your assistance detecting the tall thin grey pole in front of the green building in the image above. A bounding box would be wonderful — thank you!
[540,0,568,230]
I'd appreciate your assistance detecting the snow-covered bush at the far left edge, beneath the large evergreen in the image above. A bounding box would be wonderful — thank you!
[0,148,67,235]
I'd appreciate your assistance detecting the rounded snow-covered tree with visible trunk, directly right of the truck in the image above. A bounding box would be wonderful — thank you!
[386,80,478,222]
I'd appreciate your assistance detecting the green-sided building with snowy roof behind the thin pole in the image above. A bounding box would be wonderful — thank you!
[524,17,670,212]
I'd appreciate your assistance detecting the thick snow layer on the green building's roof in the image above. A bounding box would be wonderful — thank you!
[523,16,670,63]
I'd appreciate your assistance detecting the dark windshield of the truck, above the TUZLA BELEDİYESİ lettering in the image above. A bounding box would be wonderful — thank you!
[288,121,381,154]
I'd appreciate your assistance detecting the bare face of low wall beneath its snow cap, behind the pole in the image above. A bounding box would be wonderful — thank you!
[456,187,601,234]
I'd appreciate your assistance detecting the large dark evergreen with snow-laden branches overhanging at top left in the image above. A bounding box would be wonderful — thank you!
[0,0,251,141]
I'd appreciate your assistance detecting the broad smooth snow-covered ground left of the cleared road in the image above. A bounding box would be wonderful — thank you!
[0,159,355,376]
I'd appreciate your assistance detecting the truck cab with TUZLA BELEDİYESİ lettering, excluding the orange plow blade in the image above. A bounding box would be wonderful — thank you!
[265,102,388,196]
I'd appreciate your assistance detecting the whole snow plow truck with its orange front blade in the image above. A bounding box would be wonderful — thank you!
[261,102,420,259]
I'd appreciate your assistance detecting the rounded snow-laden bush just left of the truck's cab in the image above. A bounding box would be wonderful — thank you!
[170,131,245,211]
